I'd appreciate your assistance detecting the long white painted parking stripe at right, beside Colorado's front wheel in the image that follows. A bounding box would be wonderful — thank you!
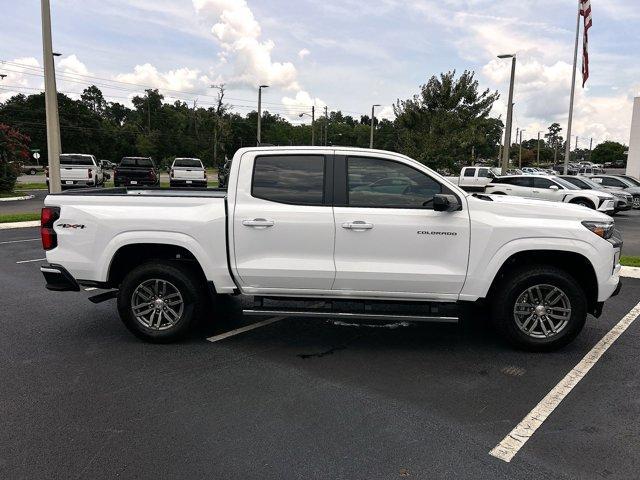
[489,303,640,462]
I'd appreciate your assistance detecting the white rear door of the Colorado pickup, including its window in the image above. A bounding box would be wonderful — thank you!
[230,150,335,294]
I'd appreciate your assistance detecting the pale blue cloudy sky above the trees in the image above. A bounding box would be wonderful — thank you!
[0,0,640,148]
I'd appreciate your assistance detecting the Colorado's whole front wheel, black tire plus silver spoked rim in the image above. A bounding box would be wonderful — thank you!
[492,265,587,351]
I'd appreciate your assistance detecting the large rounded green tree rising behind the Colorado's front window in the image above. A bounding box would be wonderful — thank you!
[394,71,502,167]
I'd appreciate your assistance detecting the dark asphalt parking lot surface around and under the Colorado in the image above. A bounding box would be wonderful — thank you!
[0,228,640,479]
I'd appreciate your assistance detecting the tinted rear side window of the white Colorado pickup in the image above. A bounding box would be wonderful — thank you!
[251,155,325,205]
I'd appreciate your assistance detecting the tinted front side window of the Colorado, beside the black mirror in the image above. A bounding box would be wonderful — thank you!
[347,157,442,208]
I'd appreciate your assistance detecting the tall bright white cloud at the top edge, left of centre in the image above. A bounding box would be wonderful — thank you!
[193,0,300,90]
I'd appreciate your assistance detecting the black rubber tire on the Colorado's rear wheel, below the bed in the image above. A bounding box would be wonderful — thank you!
[118,260,207,343]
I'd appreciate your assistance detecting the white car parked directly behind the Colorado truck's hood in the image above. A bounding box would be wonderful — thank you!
[485,175,615,214]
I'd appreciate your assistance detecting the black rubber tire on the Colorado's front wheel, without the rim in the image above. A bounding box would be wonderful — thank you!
[491,265,587,352]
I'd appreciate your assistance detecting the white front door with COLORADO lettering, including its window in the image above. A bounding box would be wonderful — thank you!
[333,154,470,299]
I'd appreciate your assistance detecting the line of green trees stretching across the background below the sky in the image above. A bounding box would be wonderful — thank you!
[0,71,628,171]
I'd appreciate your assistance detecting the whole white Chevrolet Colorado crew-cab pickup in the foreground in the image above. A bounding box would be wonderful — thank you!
[41,147,622,350]
